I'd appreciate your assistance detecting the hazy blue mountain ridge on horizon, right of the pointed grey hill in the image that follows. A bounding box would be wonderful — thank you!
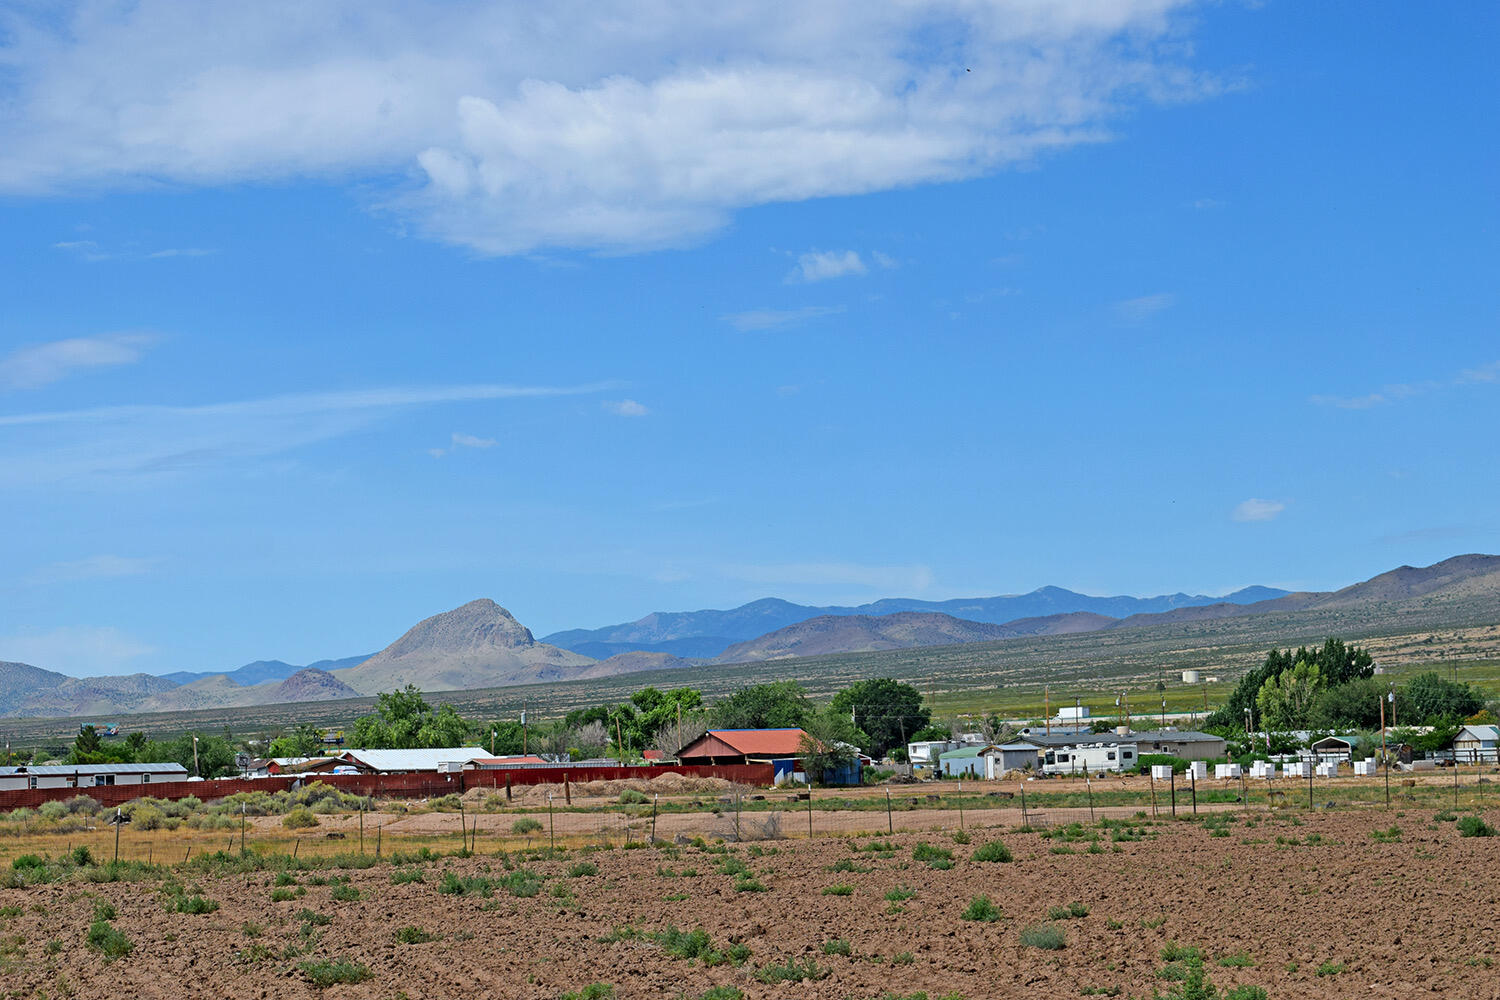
[543,586,1286,660]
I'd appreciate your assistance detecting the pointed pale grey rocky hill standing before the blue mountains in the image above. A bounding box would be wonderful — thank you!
[335,600,594,694]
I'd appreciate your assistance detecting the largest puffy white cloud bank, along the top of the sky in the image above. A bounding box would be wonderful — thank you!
[0,0,1221,253]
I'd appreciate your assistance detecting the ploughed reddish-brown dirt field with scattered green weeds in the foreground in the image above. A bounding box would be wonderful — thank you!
[0,810,1500,1000]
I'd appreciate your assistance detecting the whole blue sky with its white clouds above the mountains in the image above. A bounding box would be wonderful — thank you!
[0,0,1500,675]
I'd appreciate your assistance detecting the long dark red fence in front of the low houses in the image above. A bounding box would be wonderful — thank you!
[0,765,774,810]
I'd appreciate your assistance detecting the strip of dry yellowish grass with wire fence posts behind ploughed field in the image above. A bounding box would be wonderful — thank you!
[11,765,1500,864]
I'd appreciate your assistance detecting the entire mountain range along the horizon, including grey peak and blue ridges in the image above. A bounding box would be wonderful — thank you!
[0,555,1500,721]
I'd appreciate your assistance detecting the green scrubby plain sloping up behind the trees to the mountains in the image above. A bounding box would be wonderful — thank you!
[0,590,1500,747]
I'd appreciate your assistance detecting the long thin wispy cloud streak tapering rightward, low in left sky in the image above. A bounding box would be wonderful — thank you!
[0,382,615,489]
